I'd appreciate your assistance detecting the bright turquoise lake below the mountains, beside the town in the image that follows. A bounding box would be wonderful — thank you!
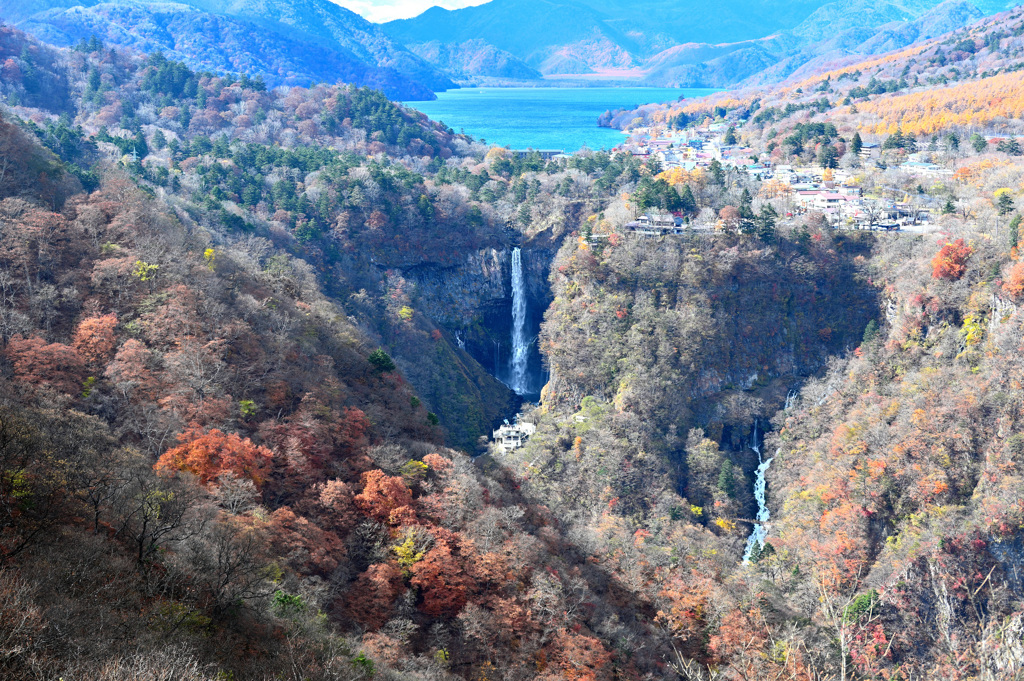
[406,87,718,153]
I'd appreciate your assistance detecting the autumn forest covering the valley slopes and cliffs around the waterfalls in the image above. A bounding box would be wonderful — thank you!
[0,14,1024,681]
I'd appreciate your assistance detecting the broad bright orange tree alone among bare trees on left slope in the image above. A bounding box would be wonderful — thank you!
[154,428,273,486]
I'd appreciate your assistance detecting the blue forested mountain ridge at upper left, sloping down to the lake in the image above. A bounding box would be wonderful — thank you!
[0,0,456,100]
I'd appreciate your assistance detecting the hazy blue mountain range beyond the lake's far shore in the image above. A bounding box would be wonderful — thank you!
[383,0,1017,87]
